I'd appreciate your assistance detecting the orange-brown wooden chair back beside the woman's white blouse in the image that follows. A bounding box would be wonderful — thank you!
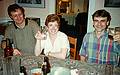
[68,36,77,59]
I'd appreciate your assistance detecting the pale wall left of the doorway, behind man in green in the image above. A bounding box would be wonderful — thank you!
[0,0,55,25]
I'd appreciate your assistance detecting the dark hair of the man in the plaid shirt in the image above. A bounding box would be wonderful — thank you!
[92,9,111,21]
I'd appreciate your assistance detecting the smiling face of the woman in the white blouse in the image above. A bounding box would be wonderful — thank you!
[47,21,59,35]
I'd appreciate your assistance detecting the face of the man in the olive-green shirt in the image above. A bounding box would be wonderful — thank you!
[10,9,24,25]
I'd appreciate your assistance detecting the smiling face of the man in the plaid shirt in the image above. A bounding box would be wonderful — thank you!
[93,17,109,32]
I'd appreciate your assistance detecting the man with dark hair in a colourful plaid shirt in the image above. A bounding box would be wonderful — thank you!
[80,9,120,65]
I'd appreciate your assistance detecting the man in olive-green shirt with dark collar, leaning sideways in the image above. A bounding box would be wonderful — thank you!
[5,4,39,55]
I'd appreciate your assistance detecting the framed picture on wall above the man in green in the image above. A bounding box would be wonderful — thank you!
[15,0,45,8]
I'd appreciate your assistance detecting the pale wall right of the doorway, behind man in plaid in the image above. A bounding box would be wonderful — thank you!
[87,0,120,32]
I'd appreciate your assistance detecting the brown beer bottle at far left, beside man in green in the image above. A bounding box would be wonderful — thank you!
[4,38,13,57]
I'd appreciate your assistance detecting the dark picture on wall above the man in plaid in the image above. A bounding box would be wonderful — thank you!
[104,0,120,7]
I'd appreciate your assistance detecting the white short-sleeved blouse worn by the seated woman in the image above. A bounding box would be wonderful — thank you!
[41,31,70,54]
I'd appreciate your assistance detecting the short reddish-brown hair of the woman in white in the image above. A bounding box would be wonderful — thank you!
[45,14,60,26]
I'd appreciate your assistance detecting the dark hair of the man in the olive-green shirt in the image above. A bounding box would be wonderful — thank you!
[7,4,25,17]
